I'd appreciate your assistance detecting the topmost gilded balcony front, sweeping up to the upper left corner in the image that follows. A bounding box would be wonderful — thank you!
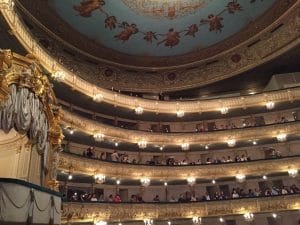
[1,4,300,113]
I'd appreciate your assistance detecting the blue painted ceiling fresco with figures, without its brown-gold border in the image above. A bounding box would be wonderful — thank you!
[49,0,276,56]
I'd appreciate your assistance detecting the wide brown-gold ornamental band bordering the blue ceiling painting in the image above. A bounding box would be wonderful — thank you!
[9,0,300,93]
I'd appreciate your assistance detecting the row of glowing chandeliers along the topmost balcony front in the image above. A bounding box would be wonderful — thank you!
[52,71,275,118]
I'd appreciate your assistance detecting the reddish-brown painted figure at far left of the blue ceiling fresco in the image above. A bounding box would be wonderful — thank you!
[73,0,105,17]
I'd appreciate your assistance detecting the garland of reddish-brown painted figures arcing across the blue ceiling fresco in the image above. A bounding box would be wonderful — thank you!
[73,0,256,48]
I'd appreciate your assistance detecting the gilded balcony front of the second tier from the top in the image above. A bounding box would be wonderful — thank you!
[62,110,300,145]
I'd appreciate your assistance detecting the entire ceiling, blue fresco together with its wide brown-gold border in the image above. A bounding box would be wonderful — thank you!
[11,0,300,93]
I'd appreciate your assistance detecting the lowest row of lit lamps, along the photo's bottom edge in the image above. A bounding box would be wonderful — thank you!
[94,212,278,225]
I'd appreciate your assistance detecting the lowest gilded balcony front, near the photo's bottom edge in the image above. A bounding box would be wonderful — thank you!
[62,195,300,223]
